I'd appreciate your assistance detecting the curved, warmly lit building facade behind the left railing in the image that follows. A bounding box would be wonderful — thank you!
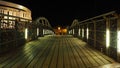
[0,1,32,29]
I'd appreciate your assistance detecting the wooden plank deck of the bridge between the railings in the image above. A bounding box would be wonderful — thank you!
[0,35,115,68]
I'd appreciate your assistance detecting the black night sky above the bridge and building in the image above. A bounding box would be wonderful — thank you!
[3,0,120,27]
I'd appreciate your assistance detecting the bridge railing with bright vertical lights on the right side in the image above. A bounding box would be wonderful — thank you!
[69,11,120,61]
